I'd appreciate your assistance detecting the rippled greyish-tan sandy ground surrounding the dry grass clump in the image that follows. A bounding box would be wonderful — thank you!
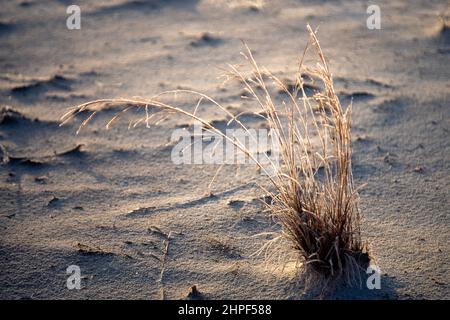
[0,0,450,299]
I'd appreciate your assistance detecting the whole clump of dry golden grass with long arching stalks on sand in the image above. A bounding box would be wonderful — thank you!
[61,26,369,284]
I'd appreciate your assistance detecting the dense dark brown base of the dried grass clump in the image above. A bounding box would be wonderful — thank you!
[269,195,371,286]
